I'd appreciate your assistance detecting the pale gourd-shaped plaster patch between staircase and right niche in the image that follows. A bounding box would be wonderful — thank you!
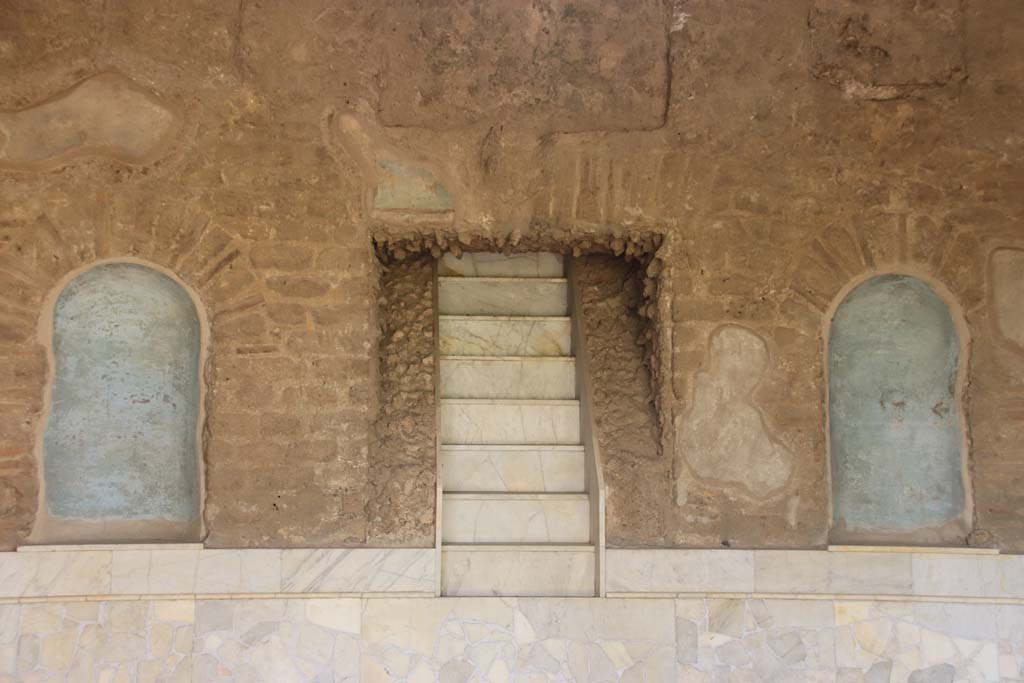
[676,325,793,499]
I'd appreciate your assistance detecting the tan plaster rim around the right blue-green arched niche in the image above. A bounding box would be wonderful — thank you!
[820,263,975,547]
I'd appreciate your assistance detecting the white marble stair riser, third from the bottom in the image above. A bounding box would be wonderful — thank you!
[441,445,587,494]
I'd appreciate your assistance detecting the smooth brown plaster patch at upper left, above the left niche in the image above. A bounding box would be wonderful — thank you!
[0,74,177,170]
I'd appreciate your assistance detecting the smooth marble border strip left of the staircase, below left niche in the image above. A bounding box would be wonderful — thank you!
[0,546,435,601]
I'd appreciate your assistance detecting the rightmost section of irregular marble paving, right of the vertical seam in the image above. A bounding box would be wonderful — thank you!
[676,598,1007,683]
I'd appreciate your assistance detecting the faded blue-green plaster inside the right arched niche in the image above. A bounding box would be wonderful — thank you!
[828,274,965,533]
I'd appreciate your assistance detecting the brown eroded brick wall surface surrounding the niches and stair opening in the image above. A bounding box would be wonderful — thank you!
[0,0,1024,549]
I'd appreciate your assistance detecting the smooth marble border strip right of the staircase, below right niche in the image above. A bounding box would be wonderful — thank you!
[607,549,1024,601]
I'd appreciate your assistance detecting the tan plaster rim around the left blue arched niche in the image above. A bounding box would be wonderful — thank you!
[27,256,211,545]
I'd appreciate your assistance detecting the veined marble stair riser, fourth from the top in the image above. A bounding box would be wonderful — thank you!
[440,355,575,398]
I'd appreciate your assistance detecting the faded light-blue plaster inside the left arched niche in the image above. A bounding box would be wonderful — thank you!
[43,263,201,521]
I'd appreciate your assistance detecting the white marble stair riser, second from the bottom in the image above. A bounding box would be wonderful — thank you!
[441,494,590,544]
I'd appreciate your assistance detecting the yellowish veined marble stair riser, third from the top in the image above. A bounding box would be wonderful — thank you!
[438,315,572,355]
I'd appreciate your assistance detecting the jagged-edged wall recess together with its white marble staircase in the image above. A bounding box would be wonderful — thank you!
[371,228,668,596]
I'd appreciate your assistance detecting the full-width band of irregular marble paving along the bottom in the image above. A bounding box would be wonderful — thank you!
[0,597,1024,683]
